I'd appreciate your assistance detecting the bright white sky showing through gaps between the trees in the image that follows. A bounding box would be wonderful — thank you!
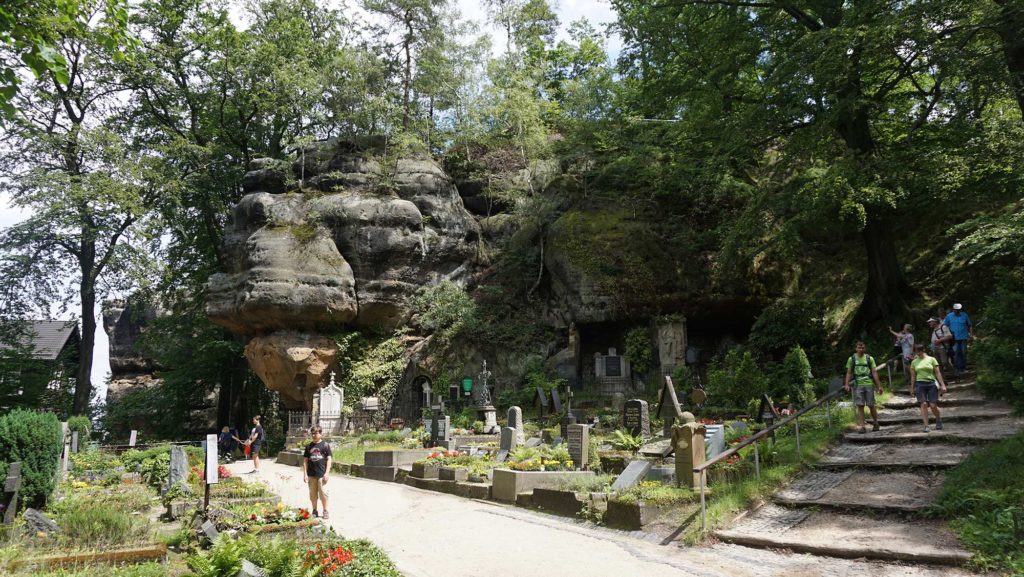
[0,0,621,398]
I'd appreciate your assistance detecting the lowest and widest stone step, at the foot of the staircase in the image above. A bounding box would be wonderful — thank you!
[715,504,971,565]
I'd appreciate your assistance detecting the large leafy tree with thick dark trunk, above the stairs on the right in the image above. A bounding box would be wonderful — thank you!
[613,0,1019,323]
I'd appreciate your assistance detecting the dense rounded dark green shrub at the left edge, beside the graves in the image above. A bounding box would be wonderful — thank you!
[0,409,63,507]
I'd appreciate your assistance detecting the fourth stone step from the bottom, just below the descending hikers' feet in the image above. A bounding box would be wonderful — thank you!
[843,416,1024,443]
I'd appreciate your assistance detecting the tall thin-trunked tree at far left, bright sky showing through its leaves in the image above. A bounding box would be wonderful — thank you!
[0,3,159,414]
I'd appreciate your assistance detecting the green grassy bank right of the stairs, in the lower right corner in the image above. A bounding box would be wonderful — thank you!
[925,432,1024,575]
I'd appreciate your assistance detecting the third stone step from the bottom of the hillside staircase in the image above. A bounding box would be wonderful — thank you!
[815,443,977,469]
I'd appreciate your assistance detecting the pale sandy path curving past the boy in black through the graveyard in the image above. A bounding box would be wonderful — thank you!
[228,460,966,577]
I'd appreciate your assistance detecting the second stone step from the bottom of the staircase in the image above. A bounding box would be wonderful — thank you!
[774,469,944,512]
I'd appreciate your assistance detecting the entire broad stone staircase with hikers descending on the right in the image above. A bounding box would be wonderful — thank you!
[715,380,1024,565]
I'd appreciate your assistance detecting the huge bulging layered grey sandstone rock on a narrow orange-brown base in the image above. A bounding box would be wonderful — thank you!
[207,140,480,406]
